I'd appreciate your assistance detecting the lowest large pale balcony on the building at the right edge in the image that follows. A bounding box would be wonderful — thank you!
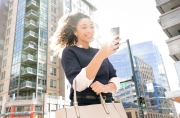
[166,35,180,61]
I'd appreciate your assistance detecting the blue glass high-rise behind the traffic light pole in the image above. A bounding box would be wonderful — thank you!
[110,41,175,114]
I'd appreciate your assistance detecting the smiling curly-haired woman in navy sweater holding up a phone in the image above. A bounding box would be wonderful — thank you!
[52,13,120,106]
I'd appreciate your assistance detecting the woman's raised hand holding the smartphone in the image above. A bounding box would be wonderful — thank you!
[98,38,121,59]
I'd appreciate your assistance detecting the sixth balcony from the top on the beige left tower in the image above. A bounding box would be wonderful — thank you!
[22,54,37,64]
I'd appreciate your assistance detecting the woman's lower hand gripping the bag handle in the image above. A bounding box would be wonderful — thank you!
[90,81,111,95]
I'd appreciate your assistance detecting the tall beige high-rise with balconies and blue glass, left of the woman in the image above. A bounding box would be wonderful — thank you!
[0,0,96,115]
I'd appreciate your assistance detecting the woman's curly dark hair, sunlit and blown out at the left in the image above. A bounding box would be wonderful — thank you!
[50,12,90,56]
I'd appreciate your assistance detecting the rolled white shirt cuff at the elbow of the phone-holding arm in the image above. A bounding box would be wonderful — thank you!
[73,68,94,92]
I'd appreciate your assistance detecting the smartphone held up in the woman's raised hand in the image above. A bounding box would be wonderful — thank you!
[110,27,120,50]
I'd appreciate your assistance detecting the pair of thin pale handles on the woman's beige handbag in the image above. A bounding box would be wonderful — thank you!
[74,79,110,118]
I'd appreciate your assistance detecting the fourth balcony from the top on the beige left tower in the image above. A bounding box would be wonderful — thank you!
[24,30,38,41]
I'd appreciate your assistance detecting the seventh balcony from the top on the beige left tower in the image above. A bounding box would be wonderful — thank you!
[21,67,37,77]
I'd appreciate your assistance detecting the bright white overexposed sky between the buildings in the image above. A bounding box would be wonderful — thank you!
[91,0,180,113]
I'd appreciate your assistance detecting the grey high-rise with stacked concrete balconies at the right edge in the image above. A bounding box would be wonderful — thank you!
[156,0,180,103]
